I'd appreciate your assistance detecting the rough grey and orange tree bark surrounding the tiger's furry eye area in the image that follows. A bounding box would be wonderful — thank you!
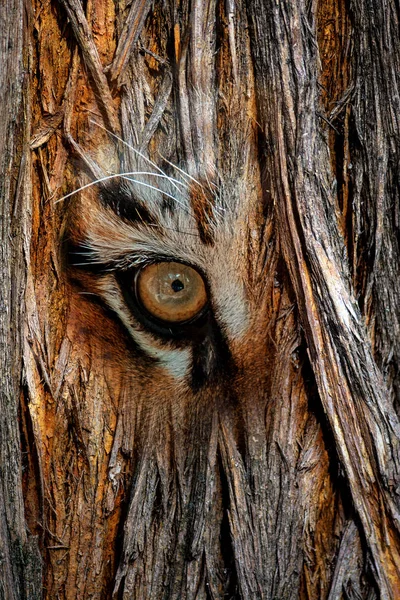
[0,0,400,600]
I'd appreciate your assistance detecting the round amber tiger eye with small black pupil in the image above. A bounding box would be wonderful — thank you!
[136,262,207,323]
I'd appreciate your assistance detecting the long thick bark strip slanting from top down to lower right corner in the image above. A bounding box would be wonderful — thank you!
[249,2,400,598]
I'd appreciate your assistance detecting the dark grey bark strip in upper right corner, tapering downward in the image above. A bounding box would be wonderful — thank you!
[348,1,400,413]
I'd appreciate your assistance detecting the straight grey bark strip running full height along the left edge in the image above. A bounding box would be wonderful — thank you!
[0,0,41,600]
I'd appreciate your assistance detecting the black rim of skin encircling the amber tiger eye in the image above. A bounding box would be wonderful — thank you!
[116,257,210,339]
